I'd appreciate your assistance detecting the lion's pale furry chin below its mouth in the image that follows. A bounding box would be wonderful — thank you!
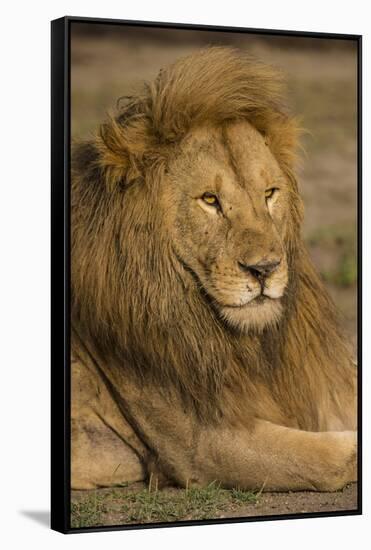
[218,298,282,333]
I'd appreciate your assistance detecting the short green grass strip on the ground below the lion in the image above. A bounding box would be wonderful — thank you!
[71,482,259,528]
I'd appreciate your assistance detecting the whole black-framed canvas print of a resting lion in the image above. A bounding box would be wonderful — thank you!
[52,17,361,532]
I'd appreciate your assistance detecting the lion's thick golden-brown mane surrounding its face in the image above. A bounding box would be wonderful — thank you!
[71,48,351,429]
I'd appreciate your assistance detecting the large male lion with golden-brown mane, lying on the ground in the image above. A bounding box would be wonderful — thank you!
[71,47,357,491]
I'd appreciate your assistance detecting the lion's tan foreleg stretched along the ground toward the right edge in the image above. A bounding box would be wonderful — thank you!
[99,379,357,491]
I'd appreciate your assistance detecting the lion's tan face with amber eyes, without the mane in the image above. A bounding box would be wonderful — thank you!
[163,122,290,331]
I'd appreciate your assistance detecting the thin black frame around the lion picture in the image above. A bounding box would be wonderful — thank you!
[51,16,362,533]
